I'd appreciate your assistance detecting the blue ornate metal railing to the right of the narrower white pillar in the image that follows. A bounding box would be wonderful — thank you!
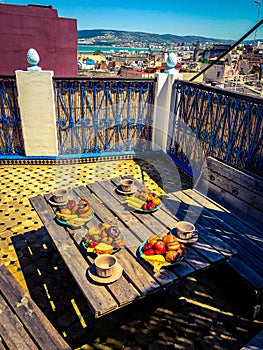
[167,81,263,176]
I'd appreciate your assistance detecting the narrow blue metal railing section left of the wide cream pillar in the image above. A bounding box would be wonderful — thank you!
[0,76,24,155]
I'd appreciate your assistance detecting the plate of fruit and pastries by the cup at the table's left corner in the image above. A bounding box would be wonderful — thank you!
[56,198,94,228]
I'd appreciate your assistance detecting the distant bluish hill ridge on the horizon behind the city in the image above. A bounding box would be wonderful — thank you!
[78,29,234,46]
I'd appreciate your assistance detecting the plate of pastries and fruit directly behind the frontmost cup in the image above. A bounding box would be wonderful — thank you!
[81,222,126,255]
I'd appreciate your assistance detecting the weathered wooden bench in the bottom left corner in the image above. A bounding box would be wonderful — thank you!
[0,265,71,350]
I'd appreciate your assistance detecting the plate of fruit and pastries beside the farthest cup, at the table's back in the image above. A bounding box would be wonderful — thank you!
[126,187,162,213]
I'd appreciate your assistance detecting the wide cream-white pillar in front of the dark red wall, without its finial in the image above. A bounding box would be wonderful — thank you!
[16,71,58,156]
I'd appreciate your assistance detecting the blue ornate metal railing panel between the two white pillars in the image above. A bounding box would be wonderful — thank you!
[54,78,156,155]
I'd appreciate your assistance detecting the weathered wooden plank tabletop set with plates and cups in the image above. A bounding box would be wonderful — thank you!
[31,179,236,317]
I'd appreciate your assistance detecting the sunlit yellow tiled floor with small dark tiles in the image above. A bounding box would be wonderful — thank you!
[0,160,157,289]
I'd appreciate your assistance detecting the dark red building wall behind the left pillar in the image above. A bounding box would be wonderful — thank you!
[0,4,78,77]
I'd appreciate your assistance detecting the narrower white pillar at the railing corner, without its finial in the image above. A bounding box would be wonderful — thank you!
[153,73,181,152]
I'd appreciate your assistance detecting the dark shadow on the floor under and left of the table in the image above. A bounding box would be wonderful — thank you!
[12,228,262,350]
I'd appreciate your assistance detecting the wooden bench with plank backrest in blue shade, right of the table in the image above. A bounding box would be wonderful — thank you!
[195,157,263,318]
